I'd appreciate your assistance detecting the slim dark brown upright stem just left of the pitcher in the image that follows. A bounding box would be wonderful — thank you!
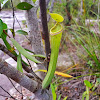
[39,0,50,68]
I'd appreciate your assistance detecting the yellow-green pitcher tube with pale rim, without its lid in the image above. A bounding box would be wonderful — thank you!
[42,23,63,89]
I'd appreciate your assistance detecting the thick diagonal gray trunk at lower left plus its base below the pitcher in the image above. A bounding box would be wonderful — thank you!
[0,59,52,100]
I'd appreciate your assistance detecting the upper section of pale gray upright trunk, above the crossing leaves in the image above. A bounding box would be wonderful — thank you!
[24,0,44,54]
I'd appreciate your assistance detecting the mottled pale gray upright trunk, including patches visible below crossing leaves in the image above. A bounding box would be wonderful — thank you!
[22,0,45,79]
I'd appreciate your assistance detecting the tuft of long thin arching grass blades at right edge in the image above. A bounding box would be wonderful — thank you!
[70,22,100,69]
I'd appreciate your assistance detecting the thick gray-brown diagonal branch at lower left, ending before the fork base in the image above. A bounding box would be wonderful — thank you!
[0,59,40,92]
